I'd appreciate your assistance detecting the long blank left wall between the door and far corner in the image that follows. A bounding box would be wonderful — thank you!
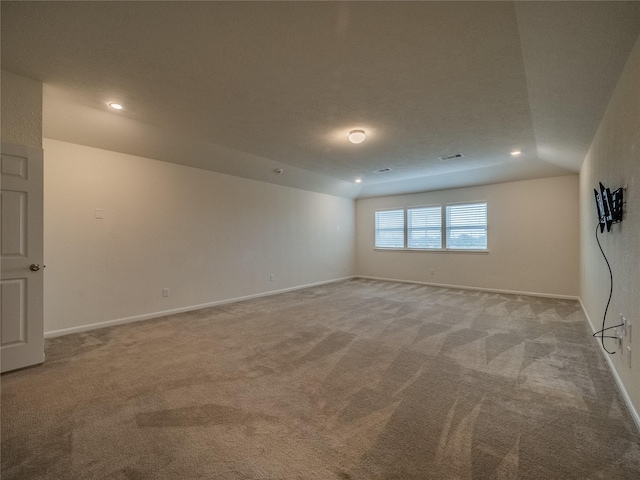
[44,139,355,333]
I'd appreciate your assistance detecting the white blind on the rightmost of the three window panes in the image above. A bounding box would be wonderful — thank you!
[445,203,487,250]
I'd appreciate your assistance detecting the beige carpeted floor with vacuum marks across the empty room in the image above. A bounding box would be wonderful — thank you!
[2,280,640,480]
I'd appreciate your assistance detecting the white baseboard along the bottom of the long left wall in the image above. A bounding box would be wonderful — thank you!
[44,276,354,338]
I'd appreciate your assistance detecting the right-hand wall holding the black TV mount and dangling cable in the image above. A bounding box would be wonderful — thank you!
[580,35,640,422]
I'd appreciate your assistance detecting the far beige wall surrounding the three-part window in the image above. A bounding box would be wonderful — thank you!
[356,175,579,297]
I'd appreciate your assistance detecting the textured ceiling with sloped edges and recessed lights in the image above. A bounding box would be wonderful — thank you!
[2,1,640,197]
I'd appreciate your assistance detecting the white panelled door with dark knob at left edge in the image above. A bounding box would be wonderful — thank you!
[0,144,44,372]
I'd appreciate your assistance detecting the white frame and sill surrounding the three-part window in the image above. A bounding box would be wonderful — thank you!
[373,200,489,254]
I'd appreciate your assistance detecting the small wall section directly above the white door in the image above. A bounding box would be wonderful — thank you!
[0,70,42,148]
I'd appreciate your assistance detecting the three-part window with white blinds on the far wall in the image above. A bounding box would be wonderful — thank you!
[375,202,487,250]
